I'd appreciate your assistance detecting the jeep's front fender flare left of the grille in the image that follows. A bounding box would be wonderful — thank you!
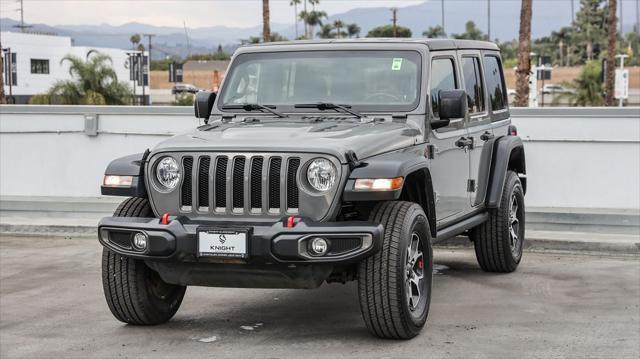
[100,150,149,198]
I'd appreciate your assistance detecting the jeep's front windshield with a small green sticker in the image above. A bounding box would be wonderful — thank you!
[218,51,420,112]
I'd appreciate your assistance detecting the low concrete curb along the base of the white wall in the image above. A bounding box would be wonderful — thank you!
[0,224,640,256]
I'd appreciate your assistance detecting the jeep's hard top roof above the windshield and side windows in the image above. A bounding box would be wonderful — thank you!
[245,38,499,51]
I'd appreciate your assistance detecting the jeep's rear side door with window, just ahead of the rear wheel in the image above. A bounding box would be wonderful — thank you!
[458,50,493,207]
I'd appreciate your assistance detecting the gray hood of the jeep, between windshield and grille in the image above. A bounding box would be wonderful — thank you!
[154,119,420,162]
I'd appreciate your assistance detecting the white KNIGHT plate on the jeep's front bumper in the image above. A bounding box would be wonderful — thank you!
[198,228,249,258]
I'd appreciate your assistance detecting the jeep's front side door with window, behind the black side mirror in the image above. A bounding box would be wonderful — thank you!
[429,51,469,226]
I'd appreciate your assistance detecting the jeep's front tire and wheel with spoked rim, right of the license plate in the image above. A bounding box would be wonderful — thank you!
[358,201,433,339]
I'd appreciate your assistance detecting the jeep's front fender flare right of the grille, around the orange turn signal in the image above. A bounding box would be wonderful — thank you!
[342,152,436,238]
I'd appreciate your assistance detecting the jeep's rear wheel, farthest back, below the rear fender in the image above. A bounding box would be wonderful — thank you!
[470,171,525,273]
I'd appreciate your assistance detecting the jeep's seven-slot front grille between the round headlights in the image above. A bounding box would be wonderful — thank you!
[180,154,300,215]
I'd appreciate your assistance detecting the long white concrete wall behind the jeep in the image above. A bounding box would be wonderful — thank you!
[0,105,640,210]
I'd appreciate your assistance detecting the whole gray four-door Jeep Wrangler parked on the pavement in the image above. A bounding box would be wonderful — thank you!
[98,39,526,339]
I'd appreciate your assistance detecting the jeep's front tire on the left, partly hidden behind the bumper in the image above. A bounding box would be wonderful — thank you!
[102,197,187,325]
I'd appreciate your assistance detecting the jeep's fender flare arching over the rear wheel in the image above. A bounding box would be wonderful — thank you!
[479,136,527,208]
